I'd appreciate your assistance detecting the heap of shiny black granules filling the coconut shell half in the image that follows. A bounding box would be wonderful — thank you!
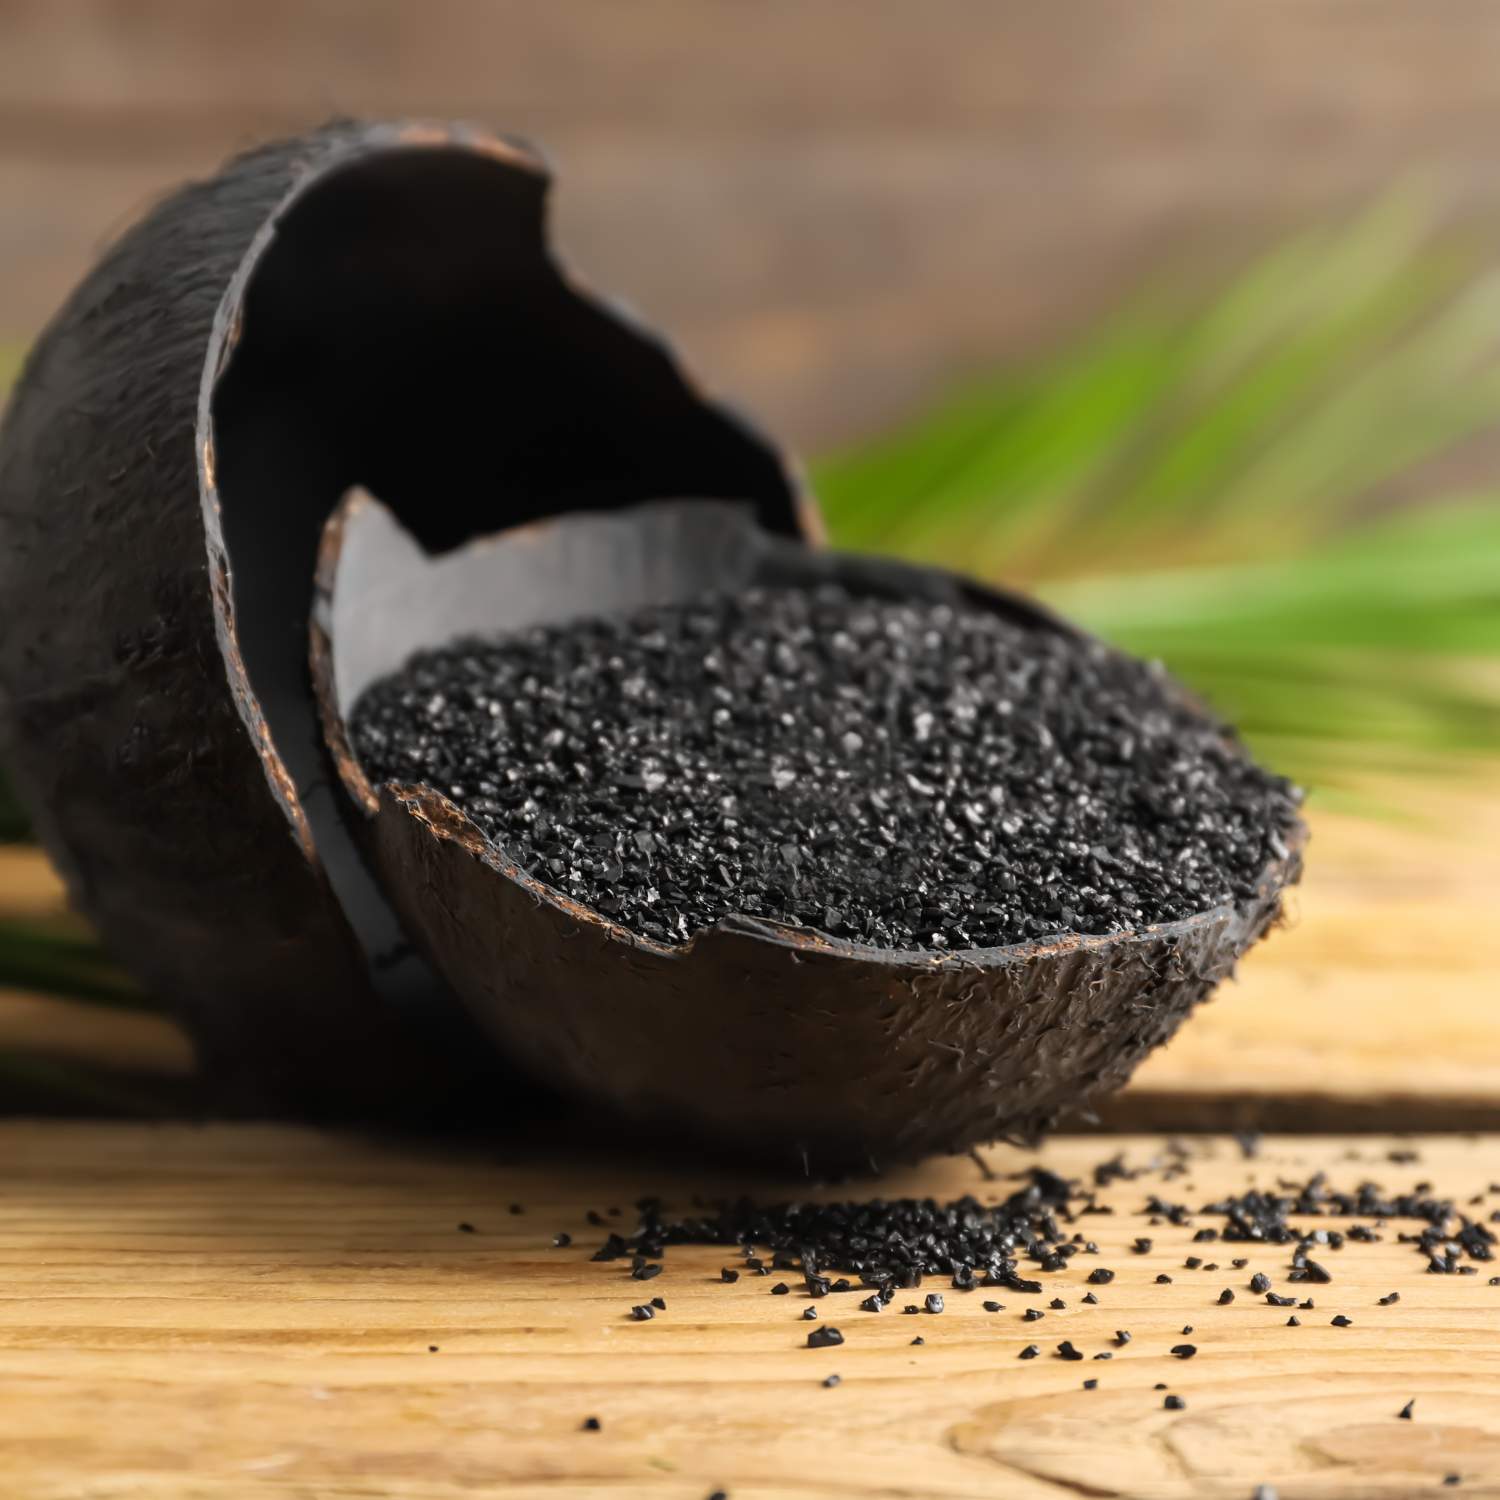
[351,587,1298,950]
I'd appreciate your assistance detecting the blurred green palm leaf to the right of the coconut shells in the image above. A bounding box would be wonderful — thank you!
[815,195,1500,788]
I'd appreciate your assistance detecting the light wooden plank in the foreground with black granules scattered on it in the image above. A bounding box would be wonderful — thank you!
[0,1124,1500,1500]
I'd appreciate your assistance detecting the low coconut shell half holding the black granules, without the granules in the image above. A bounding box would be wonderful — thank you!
[312,492,1302,1173]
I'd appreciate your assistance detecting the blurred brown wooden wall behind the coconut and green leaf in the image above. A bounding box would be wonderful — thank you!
[0,0,1500,449]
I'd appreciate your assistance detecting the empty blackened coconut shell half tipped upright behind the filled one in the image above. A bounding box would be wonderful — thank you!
[0,122,816,1118]
